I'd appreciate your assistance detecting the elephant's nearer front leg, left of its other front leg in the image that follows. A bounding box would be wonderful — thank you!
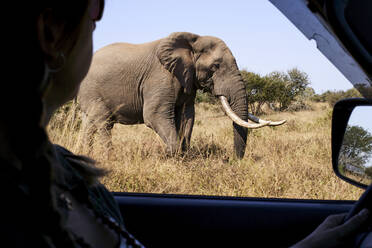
[143,97,178,155]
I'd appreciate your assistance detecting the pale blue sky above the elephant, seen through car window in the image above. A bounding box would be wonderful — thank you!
[93,0,352,94]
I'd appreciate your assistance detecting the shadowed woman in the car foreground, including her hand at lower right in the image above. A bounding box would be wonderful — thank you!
[0,0,367,247]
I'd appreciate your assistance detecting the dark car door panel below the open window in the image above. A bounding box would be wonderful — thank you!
[115,193,354,247]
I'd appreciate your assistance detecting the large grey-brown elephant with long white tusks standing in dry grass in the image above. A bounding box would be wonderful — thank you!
[77,32,285,158]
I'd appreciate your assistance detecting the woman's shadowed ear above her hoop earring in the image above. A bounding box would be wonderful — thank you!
[37,9,63,63]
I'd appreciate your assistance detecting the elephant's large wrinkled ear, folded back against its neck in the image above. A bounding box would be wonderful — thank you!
[157,32,199,94]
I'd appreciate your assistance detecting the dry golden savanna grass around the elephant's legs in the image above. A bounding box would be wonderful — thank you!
[48,103,362,200]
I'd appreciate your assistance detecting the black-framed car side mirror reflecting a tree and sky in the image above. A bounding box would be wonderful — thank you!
[332,98,372,189]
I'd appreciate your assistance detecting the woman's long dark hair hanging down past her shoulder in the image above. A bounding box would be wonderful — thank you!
[0,0,102,247]
